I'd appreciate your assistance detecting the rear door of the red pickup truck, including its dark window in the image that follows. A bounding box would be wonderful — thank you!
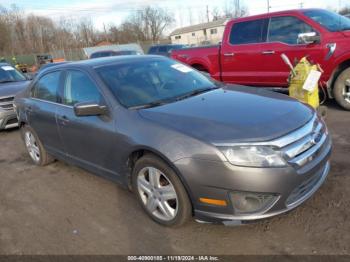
[220,19,268,85]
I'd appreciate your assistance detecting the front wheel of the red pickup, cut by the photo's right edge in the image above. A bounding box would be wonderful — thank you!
[333,68,350,111]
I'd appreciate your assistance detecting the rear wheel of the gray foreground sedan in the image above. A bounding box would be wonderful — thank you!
[21,125,55,166]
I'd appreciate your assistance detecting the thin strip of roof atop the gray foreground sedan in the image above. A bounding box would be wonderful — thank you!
[37,55,168,72]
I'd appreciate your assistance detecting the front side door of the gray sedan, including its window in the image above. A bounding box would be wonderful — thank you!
[57,70,116,177]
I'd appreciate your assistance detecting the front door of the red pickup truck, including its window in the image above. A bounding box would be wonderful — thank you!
[261,15,327,86]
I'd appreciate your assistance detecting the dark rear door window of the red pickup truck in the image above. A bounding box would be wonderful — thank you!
[230,19,268,45]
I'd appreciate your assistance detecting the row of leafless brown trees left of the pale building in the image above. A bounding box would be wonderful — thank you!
[0,5,174,56]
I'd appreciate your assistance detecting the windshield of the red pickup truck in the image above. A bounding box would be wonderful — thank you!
[304,10,350,32]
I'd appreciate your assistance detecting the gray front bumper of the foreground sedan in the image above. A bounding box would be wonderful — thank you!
[174,116,332,225]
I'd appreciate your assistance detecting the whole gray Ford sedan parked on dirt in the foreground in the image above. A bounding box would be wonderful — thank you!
[15,56,331,226]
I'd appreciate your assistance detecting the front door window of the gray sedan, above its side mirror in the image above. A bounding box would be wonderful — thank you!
[62,70,102,106]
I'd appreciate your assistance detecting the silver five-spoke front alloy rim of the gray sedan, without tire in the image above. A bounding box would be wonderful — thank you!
[137,167,179,221]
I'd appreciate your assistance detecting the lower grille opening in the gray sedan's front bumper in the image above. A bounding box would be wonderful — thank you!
[286,163,329,207]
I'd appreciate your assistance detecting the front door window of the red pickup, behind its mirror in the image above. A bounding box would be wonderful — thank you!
[268,16,315,45]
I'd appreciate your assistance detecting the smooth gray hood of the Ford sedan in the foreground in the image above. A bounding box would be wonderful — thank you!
[139,86,314,143]
